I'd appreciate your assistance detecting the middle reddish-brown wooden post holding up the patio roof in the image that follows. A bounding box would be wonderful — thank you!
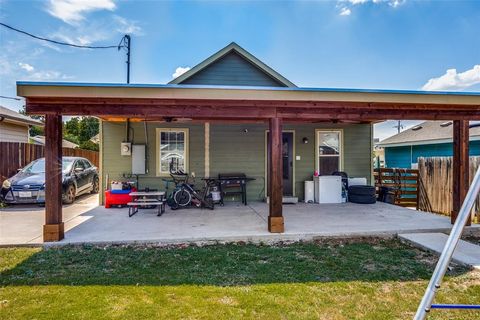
[268,118,285,233]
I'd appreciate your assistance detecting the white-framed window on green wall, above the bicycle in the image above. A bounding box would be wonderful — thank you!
[157,128,188,175]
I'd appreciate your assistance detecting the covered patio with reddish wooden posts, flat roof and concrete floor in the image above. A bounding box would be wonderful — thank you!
[17,82,480,242]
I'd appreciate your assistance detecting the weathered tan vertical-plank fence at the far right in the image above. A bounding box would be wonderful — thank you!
[418,157,480,219]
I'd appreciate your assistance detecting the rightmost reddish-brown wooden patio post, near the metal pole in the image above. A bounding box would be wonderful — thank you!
[450,120,471,226]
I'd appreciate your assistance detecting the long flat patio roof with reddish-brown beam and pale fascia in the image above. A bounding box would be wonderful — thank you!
[17,82,480,122]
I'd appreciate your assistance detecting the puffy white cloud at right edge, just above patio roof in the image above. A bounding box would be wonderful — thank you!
[422,64,480,91]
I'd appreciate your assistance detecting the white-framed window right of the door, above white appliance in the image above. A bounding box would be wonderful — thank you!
[316,130,342,175]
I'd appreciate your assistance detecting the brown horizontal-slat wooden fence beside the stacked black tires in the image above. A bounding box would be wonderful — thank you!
[373,168,419,209]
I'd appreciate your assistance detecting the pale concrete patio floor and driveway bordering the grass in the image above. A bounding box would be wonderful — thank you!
[0,197,480,245]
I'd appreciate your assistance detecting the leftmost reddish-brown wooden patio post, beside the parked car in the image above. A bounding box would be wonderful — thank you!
[43,114,64,242]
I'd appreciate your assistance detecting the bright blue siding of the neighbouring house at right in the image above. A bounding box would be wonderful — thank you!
[385,141,480,168]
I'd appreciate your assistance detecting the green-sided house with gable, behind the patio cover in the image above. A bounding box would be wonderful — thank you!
[100,43,373,201]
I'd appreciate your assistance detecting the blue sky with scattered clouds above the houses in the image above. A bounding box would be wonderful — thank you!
[0,0,480,138]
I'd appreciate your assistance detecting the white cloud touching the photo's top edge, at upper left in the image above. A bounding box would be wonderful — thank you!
[47,0,116,24]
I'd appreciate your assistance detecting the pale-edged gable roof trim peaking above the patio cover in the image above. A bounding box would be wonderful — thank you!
[169,42,296,87]
